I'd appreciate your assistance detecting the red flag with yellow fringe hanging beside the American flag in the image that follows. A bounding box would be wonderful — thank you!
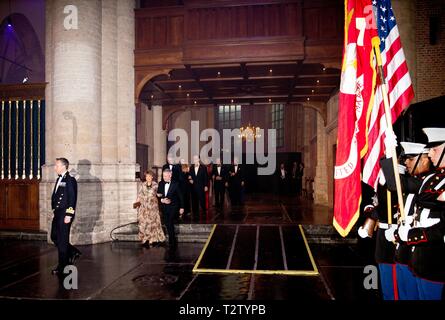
[333,0,379,237]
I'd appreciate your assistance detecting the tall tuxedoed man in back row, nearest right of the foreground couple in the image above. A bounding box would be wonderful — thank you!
[190,155,209,218]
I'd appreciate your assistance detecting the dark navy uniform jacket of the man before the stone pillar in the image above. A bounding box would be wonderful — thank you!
[51,172,77,218]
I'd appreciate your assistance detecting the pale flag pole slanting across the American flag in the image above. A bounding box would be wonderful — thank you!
[374,46,405,224]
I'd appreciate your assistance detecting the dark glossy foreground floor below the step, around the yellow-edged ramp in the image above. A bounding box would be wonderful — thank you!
[0,239,380,301]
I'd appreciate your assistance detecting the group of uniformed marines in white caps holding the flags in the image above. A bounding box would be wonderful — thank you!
[358,128,445,300]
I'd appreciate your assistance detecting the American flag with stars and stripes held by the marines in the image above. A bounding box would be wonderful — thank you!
[362,0,414,189]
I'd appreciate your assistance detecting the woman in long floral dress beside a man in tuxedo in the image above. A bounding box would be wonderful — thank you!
[136,170,165,248]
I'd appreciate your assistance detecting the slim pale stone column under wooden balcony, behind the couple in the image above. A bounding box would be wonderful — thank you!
[152,106,167,180]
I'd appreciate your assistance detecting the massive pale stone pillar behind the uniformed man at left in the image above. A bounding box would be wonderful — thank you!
[40,0,137,244]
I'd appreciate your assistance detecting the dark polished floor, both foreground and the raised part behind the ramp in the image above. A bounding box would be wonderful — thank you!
[0,194,380,301]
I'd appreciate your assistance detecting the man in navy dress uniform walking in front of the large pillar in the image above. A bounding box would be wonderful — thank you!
[51,158,81,274]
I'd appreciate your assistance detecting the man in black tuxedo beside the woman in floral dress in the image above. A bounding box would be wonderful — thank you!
[157,169,184,248]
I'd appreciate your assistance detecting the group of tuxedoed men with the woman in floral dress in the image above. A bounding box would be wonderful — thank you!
[135,156,244,248]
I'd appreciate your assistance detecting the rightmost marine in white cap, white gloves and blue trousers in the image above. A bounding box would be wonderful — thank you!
[397,128,445,300]
